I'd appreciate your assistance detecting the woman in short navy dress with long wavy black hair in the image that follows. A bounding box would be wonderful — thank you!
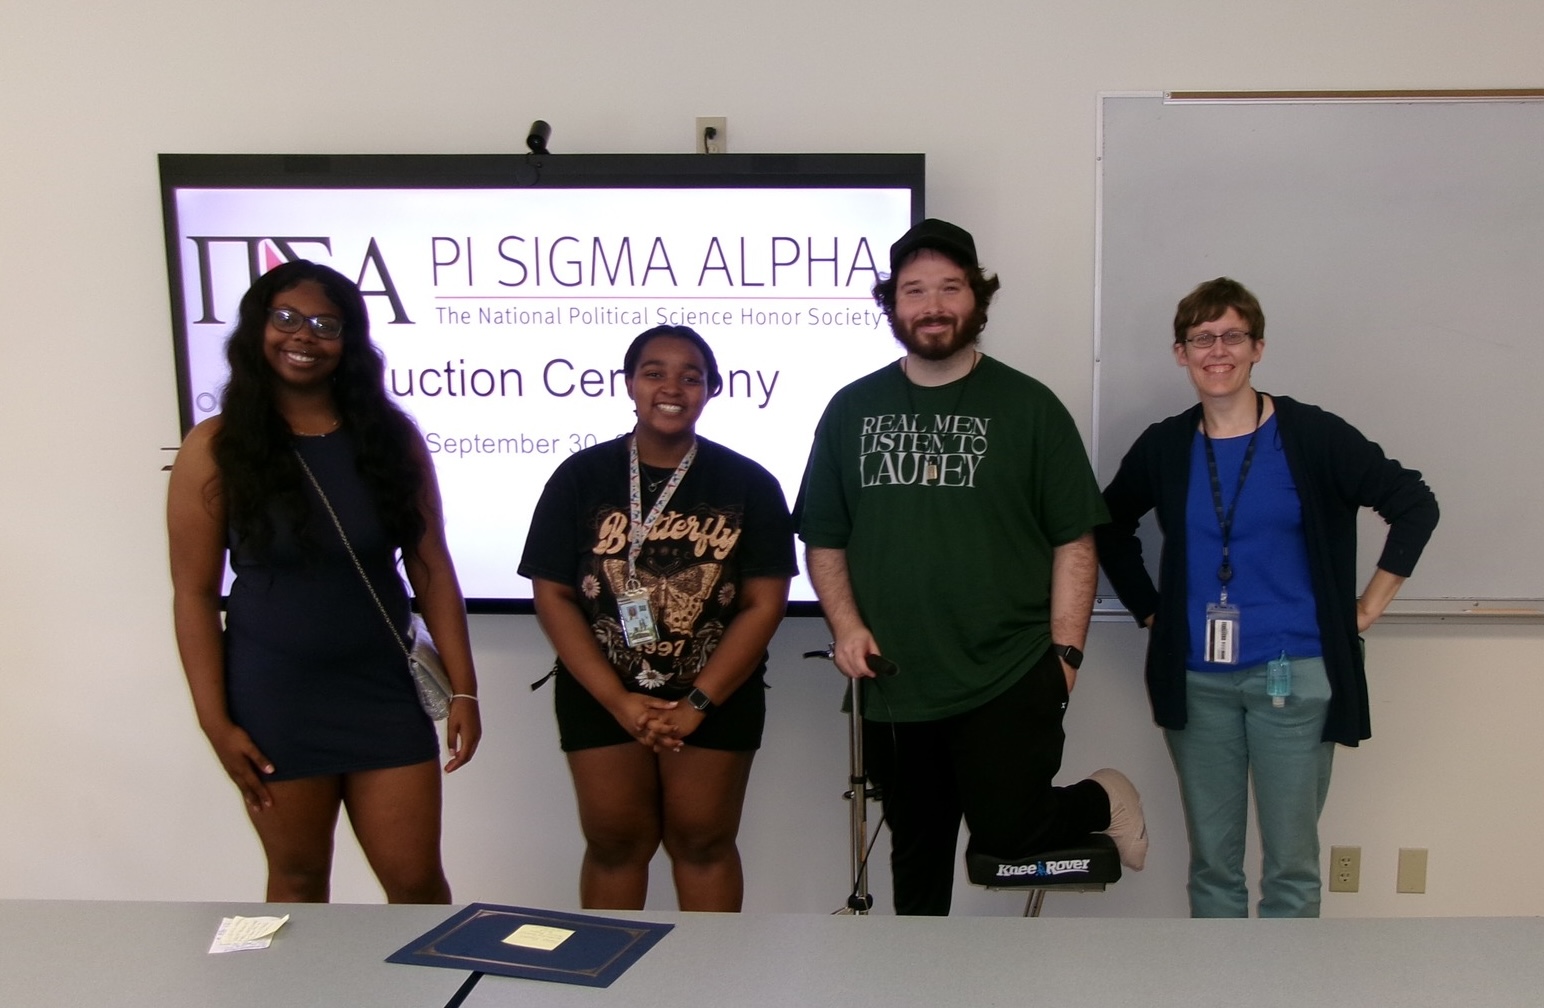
[167,261,482,903]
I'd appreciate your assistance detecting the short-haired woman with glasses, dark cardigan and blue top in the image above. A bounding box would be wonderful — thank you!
[1096,276,1437,917]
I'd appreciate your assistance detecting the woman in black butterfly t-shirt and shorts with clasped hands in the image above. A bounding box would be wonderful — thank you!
[520,326,797,911]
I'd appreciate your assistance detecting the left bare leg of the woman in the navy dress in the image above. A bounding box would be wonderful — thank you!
[247,776,343,903]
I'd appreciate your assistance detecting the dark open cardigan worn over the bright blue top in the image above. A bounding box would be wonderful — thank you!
[1095,395,1437,746]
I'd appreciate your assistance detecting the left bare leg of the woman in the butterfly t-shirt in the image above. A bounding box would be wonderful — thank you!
[568,742,663,909]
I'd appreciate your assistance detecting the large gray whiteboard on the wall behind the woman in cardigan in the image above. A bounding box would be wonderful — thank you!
[1093,96,1544,600]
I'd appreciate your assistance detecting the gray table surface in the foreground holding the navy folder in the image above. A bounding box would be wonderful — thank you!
[0,900,1544,1008]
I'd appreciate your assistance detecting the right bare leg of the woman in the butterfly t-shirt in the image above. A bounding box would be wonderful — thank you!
[659,744,755,911]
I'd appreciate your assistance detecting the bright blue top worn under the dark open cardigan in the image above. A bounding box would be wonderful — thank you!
[1184,415,1323,671]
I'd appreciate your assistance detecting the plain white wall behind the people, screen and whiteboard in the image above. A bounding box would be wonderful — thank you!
[0,0,1544,915]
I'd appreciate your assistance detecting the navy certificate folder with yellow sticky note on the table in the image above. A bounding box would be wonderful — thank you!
[386,903,675,986]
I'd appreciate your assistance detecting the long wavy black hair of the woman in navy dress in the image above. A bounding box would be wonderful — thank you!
[213,259,428,554]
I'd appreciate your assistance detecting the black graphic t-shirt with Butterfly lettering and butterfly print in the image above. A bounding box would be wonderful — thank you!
[519,437,798,699]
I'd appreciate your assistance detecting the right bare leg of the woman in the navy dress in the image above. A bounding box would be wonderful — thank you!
[343,759,451,903]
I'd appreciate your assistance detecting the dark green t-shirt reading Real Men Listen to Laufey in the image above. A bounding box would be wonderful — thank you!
[797,357,1109,721]
